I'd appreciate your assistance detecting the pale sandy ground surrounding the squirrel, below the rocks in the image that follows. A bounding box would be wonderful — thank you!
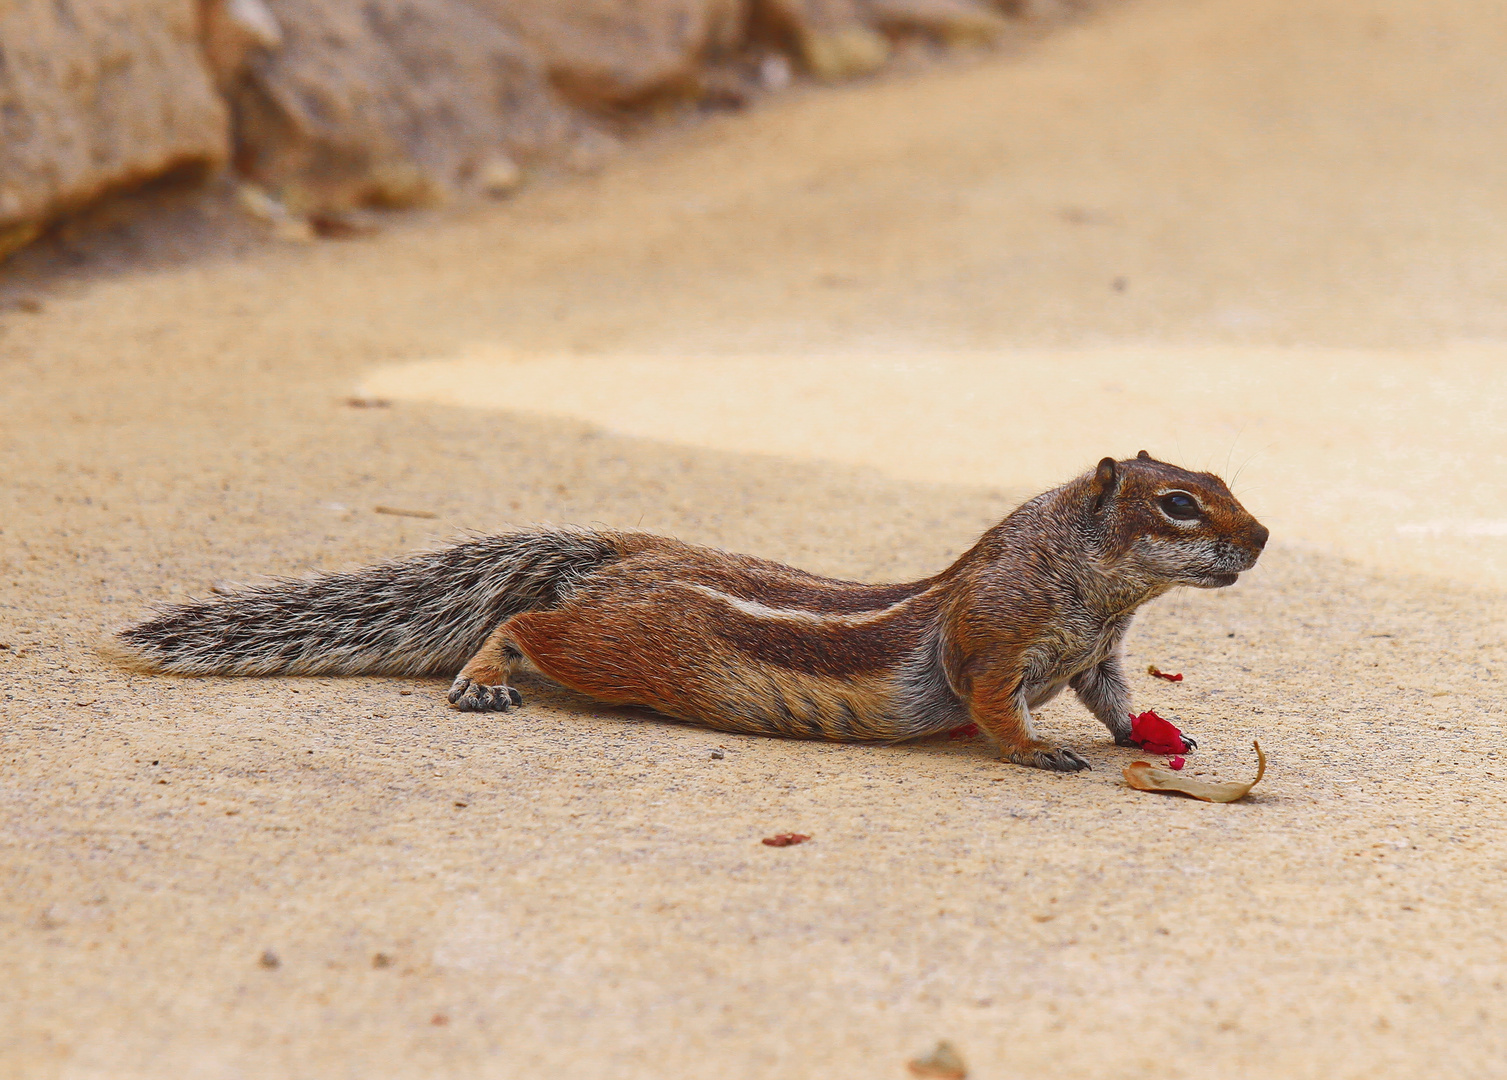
[0,0,1507,1080]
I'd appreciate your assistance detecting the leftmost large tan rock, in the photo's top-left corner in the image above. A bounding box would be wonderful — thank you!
[0,0,231,258]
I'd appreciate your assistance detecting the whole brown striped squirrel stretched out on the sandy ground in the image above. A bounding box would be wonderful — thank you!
[118,450,1269,773]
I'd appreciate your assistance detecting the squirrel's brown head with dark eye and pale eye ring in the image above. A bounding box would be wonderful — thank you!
[1087,450,1270,589]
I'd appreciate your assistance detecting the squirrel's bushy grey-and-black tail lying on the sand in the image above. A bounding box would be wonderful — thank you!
[118,529,618,675]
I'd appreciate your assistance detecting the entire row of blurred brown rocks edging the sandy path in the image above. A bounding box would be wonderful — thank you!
[0,0,1060,258]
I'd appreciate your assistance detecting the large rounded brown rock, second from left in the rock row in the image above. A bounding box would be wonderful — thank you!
[232,0,580,214]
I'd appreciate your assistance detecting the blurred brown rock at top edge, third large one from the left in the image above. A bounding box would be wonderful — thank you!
[476,0,747,107]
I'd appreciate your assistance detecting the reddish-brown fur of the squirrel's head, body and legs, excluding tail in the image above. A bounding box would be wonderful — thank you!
[452,456,1267,770]
